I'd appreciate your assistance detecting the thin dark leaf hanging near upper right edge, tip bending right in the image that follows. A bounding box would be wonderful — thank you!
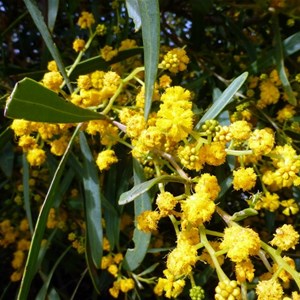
[272,14,297,106]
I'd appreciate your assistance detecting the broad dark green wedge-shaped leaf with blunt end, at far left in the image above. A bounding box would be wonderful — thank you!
[4,78,106,123]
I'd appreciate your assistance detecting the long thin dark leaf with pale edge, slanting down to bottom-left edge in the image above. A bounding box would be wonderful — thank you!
[17,125,81,300]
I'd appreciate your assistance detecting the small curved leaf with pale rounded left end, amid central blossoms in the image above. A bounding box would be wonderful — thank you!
[119,175,186,205]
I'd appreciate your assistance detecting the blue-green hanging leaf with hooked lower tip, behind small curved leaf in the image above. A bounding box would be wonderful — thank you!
[124,159,151,271]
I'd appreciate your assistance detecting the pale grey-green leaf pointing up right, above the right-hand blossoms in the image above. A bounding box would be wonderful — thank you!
[195,72,248,130]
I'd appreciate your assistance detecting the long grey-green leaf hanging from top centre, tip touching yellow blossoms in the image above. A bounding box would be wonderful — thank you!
[138,0,160,119]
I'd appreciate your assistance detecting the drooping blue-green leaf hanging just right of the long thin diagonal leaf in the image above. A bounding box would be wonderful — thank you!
[79,132,103,268]
